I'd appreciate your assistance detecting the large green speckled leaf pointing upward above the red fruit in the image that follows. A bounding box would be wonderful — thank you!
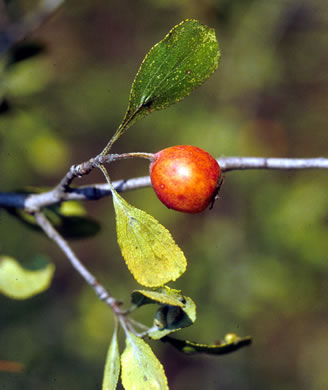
[107,19,220,151]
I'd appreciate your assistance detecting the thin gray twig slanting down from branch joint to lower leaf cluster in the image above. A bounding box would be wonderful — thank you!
[34,212,122,315]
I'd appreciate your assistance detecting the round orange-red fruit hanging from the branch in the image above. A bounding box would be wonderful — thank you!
[149,145,221,213]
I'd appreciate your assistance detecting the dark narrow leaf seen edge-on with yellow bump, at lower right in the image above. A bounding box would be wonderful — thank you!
[161,333,252,355]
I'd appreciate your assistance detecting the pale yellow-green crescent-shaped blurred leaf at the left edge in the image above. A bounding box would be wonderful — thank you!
[0,256,55,299]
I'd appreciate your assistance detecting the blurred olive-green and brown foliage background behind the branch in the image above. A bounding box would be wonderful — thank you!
[0,0,328,390]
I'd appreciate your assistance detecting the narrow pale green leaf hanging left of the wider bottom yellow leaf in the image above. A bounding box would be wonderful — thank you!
[102,326,120,390]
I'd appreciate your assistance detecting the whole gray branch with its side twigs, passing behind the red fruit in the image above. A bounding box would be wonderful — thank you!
[0,154,328,328]
